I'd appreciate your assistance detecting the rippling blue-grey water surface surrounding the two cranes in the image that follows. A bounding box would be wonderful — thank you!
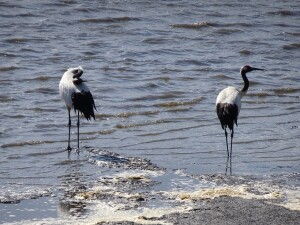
[0,0,300,222]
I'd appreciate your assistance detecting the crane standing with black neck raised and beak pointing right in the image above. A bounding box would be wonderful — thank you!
[216,65,263,174]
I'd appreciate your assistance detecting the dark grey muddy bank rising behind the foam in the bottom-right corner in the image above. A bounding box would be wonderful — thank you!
[98,197,300,225]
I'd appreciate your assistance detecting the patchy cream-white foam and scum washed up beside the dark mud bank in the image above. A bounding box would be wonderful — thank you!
[63,171,298,224]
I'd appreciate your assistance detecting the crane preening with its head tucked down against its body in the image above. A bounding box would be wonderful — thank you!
[59,66,96,150]
